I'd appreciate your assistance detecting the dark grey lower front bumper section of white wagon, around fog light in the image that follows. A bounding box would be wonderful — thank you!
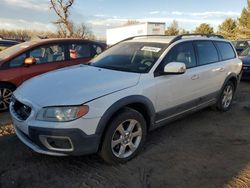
[14,125,100,156]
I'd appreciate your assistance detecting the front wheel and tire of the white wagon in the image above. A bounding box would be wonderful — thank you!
[100,108,147,164]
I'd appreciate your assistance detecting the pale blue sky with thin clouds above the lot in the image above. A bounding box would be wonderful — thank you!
[0,0,247,38]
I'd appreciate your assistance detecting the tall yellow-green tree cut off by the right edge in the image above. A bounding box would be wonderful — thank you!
[237,0,250,38]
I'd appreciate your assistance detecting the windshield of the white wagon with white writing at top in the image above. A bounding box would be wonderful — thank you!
[90,42,167,73]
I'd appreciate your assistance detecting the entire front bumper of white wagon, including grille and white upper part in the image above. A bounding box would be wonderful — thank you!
[10,95,101,156]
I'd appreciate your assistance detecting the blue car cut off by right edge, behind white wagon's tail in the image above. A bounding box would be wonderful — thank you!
[240,47,250,80]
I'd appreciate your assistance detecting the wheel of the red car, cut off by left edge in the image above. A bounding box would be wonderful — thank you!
[0,83,15,112]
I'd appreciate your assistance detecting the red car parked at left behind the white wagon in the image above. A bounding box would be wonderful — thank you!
[0,39,106,111]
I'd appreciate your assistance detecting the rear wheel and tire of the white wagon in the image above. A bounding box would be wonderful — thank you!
[217,81,235,112]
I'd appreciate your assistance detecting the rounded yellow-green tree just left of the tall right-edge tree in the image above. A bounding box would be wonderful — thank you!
[218,18,237,40]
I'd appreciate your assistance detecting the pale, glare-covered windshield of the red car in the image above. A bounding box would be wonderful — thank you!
[0,41,36,61]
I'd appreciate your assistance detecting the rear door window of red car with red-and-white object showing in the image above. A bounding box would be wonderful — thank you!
[69,44,92,59]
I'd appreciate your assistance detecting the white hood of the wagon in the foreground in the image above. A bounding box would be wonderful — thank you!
[14,65,140,107]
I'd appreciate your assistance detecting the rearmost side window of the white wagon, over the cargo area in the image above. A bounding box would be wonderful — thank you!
[215,42,236,60]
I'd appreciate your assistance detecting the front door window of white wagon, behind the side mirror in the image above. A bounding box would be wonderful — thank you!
[162,42,196,68]
